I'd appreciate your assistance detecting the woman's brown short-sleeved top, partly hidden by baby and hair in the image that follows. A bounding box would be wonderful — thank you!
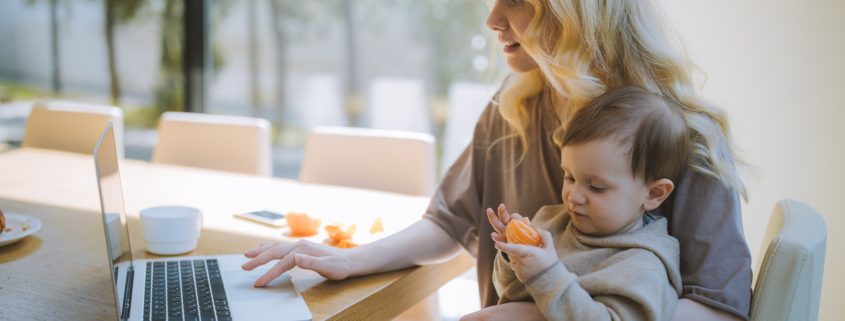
[425,94,752,319]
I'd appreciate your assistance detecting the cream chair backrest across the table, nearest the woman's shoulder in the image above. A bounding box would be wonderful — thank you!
[299,127,435,196]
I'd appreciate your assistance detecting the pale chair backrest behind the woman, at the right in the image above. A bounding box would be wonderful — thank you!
[751,200,827,321]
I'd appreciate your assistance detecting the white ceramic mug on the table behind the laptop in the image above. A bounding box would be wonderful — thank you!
[140,206,202,255]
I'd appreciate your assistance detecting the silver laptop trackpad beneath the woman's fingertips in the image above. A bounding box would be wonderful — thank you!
[223,270,298,302]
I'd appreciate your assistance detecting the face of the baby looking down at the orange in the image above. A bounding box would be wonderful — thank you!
[561,139,651,235]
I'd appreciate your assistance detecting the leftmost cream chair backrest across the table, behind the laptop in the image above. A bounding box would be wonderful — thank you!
[21,100,123,158]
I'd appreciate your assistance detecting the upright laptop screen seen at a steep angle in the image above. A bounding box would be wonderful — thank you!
[94,123,132,318]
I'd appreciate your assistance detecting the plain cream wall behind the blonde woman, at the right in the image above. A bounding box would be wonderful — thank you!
[663,0,845,320]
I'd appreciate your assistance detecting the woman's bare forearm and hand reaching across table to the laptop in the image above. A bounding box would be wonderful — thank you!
[242,219,460,287]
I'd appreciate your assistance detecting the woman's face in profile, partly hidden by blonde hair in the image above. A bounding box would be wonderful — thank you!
[487,0,537,72]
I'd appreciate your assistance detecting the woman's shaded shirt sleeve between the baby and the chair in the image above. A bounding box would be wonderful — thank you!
[655,170,752,318]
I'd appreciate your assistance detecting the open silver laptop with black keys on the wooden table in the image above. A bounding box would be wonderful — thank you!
[94,124,312,321]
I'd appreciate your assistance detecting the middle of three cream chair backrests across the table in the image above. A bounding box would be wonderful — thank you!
[152,112,273,176]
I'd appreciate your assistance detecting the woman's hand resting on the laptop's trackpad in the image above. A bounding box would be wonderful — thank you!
[241,240,352,287]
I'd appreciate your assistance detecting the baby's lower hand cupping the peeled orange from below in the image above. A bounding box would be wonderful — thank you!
[494,229,560,282]
